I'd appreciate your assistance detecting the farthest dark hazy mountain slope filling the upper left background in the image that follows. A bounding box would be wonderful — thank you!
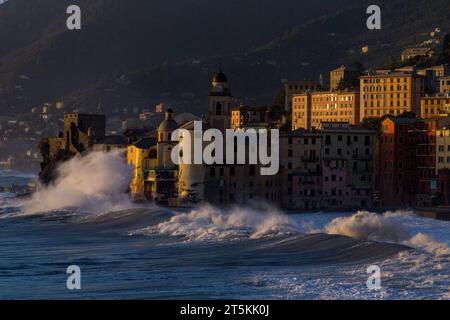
[0,0,356,112]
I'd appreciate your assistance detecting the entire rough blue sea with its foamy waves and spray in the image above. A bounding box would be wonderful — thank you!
[0,168,450,300]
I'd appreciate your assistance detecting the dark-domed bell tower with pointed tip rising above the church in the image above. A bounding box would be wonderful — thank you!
[208,67,232,131]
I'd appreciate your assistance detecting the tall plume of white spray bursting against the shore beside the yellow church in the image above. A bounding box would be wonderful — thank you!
[21,151,133,215]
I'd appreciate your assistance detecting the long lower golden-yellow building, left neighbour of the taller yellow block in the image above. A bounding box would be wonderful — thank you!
[292,91,360,130]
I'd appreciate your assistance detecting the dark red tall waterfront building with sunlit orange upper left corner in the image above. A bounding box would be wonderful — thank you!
[378,117,420,207]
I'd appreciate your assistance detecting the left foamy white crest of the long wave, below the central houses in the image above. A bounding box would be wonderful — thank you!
[135,204,299,241]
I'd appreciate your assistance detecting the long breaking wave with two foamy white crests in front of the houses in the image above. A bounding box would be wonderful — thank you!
[129,204,450,258]
